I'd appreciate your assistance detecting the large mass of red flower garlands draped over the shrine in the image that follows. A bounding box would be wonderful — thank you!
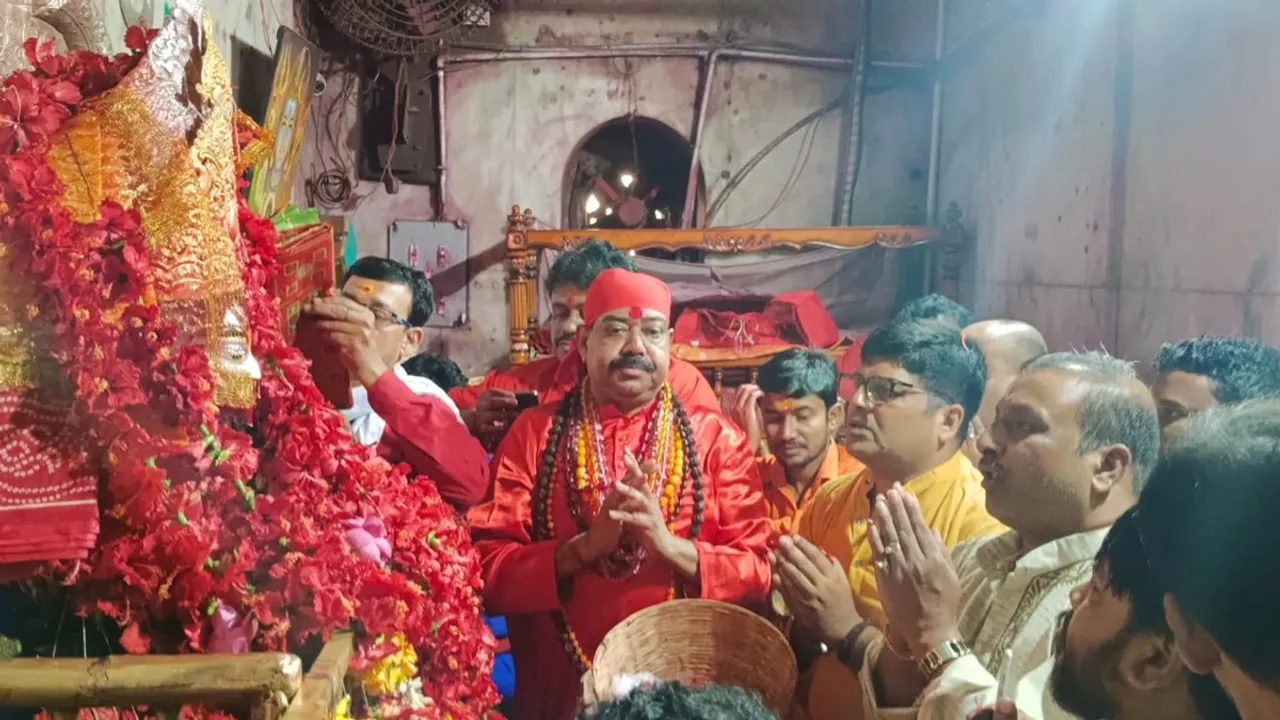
[0,28,498,717]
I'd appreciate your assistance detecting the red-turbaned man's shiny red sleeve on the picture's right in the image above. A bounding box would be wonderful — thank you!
[695,419,773,605]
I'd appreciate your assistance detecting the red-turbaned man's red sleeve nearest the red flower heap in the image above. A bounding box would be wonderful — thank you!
[467,411,561,615]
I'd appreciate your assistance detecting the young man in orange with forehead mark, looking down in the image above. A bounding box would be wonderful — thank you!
[733,350,863,534]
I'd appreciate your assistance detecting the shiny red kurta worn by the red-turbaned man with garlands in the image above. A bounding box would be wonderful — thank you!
[470,394,773,720]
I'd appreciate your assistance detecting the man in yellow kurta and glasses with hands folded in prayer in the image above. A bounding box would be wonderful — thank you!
[774,320,1005,720]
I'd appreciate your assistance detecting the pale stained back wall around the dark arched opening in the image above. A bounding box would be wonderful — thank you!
[302,0,933,373]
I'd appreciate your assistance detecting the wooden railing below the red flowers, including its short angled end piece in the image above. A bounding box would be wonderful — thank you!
[0,633,353,720]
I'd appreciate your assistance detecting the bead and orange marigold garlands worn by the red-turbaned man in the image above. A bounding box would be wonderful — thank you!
[534,379,705,673]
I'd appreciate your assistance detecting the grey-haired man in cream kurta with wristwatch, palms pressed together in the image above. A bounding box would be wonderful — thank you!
[860,352,1160,720]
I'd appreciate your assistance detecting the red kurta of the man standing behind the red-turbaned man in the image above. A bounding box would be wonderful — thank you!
[449,355,721,410]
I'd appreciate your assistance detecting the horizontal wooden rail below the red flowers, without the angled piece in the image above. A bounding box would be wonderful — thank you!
[0,652,302,710]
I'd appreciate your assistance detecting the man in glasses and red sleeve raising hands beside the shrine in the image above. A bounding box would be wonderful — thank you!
[303,258,489,510]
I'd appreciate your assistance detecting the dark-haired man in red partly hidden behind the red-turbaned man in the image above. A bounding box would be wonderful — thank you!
[449,240,719,439]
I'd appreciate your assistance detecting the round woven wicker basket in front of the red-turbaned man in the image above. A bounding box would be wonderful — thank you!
[584,600,796,714]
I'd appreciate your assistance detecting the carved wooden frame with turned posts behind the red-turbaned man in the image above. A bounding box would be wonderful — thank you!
[507,204,966,392]
